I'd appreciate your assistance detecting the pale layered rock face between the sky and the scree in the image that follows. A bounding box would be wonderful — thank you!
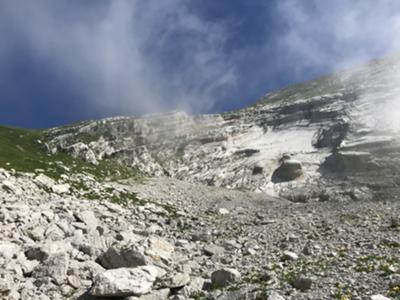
[44,57,400,197]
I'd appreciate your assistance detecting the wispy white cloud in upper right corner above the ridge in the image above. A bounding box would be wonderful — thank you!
[277,0,400,78]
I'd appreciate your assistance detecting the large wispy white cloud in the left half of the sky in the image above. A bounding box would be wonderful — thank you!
[0,0,236,114]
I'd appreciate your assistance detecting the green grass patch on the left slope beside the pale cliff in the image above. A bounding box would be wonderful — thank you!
[0,126,141,181]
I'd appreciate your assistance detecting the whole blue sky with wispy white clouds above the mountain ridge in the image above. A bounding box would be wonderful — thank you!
[0,0,400,127]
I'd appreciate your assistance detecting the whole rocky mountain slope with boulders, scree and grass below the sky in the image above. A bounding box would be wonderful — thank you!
[0,57,400,300]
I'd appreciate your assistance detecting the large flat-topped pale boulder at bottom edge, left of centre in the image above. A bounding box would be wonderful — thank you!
[90,266,158,297]
